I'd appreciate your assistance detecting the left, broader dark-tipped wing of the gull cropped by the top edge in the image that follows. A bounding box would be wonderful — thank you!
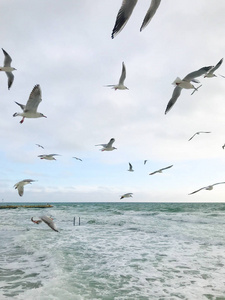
[112,0,138,39]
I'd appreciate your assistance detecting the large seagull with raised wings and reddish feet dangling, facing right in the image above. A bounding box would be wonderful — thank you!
[13,84,47,124]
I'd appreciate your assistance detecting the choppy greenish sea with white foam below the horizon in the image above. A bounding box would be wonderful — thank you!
[0,203,225,300]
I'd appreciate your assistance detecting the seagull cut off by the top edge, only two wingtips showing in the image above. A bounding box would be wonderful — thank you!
[111,0,161,39]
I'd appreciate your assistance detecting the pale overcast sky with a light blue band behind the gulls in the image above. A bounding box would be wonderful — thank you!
[0,0,225,202]
